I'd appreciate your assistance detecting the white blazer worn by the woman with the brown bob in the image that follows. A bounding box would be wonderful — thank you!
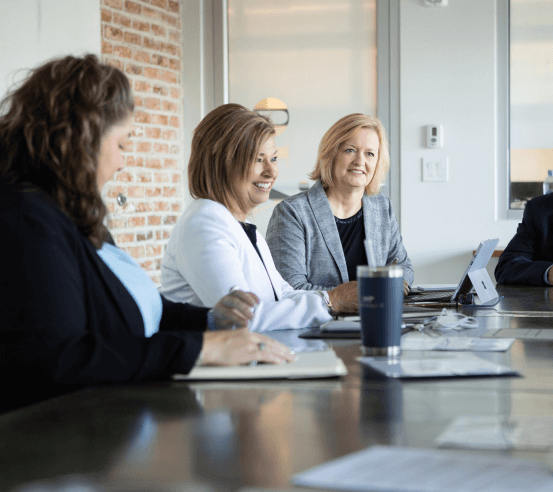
[160,199,331,332]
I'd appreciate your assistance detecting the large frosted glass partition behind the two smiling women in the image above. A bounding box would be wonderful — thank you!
[228,0,378,233]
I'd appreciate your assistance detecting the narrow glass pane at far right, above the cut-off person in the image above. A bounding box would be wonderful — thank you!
[509,0,553,209]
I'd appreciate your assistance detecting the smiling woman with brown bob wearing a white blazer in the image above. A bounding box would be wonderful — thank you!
[161,104,357,332]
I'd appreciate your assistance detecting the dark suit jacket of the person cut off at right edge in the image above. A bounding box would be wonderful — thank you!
[495,194,553,285]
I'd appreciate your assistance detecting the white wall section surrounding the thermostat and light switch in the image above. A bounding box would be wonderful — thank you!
[400,0,518,283]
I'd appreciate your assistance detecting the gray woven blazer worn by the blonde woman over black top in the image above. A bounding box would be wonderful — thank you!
[267,182,414,290]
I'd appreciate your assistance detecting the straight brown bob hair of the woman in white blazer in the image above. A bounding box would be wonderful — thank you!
[188,104,275,213]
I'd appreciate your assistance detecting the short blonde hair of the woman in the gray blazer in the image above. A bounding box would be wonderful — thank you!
[309,113,390,195]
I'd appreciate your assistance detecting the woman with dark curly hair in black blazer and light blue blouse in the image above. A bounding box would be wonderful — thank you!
[0,55,293,411]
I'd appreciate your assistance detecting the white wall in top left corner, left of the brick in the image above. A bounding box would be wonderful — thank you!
[0,0,101,97]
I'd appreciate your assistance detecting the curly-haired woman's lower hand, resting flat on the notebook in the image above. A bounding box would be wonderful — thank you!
[202,328,295,366]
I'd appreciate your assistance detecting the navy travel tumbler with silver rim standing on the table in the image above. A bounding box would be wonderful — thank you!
[357,265,403,357]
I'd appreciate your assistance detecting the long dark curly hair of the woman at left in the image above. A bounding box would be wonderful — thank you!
[0,55,134,248]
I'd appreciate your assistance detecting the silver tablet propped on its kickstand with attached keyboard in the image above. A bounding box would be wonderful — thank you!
[404,239,500,306]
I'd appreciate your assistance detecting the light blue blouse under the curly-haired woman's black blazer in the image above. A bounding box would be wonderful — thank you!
[98,243,163,337]
